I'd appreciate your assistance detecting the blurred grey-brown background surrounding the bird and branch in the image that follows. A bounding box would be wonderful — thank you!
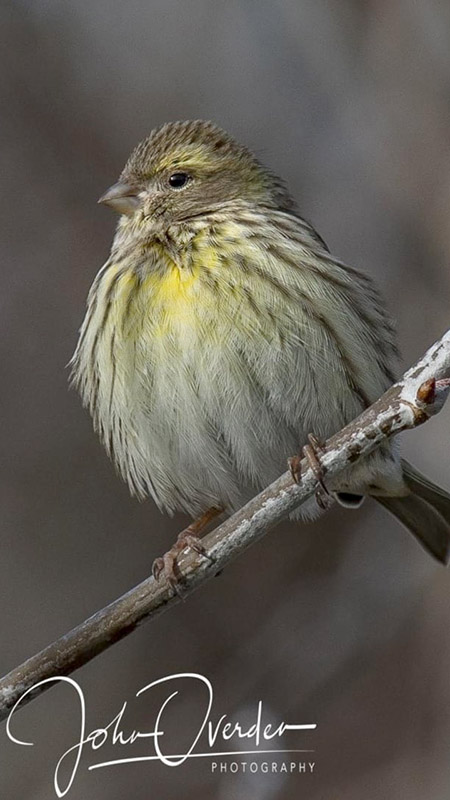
[0,0,450,800]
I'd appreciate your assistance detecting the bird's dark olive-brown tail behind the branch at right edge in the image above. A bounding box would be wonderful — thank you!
[372,459,450,564]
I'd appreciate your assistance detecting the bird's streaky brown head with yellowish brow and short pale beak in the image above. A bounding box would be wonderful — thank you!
[99,120,294,224]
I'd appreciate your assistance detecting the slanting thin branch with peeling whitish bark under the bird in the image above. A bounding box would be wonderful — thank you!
[0,330,450,719]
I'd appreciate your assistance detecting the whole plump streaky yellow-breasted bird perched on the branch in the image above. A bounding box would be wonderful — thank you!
[71,120,450,587]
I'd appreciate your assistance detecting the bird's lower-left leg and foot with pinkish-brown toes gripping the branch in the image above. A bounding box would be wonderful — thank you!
[152,508,223,597]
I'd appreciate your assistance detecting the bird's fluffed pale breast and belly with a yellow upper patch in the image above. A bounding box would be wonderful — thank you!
[74,227,404,515]
